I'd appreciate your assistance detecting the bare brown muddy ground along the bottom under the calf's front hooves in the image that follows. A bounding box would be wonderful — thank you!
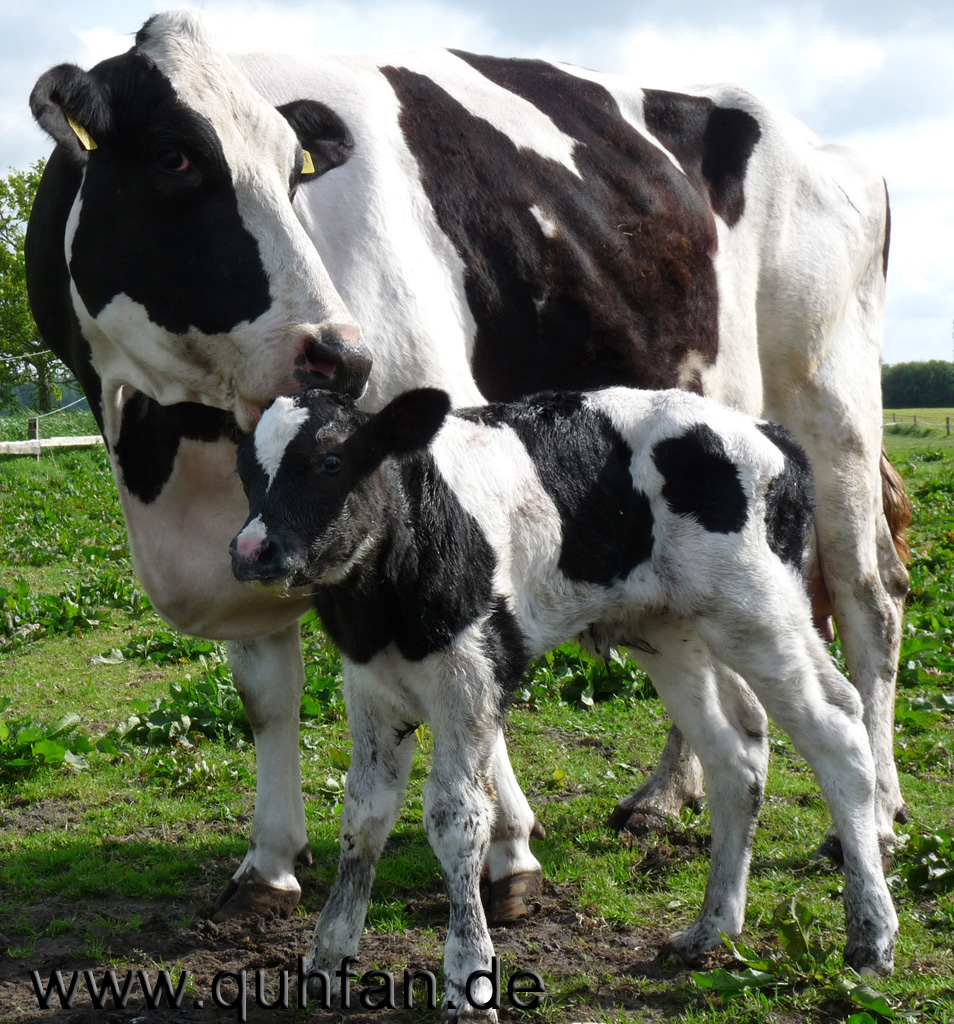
[0,864,716,1024]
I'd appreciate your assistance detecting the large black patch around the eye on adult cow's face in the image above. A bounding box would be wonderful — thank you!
[51,51,271,334]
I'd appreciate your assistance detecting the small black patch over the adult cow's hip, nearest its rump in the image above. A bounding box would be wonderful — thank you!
[643,89,762,226]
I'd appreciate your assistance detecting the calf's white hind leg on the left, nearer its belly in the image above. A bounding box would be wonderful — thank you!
[634,616,768,964]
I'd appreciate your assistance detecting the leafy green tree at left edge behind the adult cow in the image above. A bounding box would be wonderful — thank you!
[0,161,70,413]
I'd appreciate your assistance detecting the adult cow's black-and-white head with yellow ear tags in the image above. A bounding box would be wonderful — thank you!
[31,11,371,427]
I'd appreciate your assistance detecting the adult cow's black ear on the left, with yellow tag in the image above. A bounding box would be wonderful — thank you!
[30,65,110,163]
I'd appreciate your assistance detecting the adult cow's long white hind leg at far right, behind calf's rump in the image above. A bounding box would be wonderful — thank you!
[758,186,908,845]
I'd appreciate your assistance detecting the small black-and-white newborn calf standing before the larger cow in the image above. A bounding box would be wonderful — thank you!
[231,388,897,1007]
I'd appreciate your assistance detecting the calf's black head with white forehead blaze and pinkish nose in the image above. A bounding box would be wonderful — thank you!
[229,388,450,587]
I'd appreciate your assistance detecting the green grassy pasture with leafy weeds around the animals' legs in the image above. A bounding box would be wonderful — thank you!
[0,410,954,1024]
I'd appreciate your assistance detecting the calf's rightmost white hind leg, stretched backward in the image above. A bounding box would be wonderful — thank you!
[698,582,898,974]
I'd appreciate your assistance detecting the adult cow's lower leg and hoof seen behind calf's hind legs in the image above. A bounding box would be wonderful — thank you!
[609,725,705,836]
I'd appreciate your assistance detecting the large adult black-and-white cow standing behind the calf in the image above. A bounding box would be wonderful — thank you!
[27,11,907,916]
